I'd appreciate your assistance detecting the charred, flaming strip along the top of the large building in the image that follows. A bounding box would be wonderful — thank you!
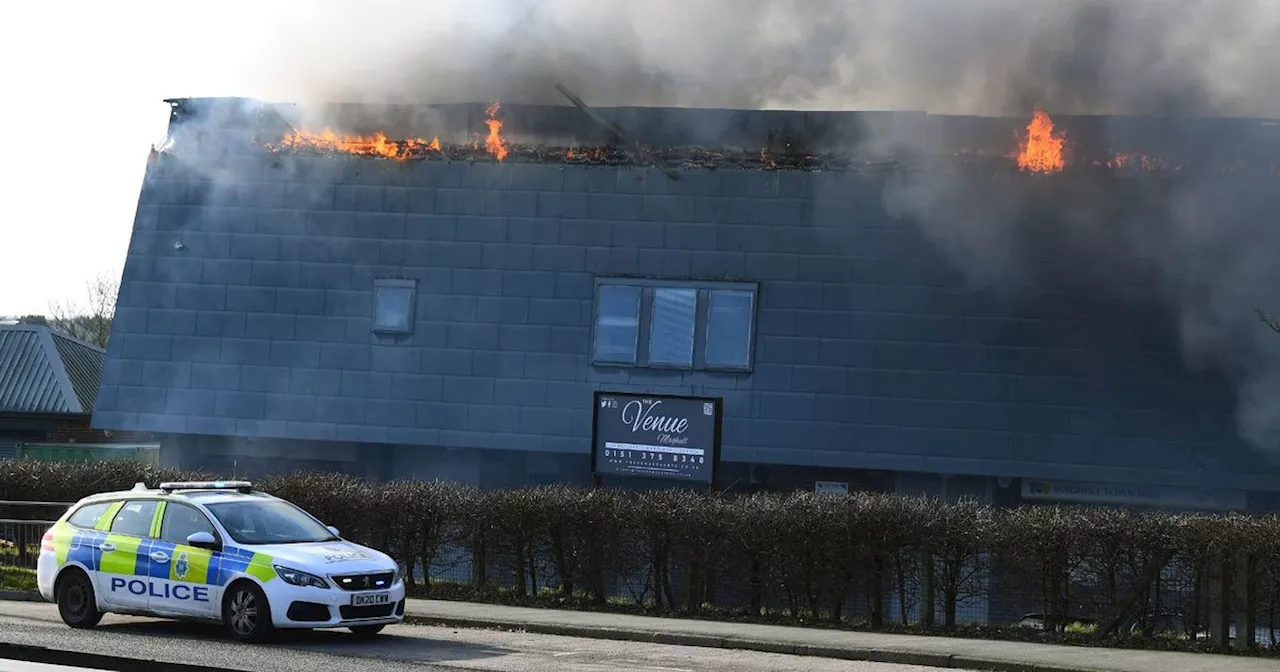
[157,96,1280,175]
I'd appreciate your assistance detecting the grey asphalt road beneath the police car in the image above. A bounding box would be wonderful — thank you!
[0,602,962,672]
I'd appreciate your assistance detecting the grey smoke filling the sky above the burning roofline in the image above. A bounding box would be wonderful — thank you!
[257,0,1280,116]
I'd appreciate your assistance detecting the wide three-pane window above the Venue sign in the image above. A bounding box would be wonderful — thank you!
[591,278,758,371]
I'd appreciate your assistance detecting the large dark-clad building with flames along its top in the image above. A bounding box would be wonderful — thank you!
[93,99,1280,509]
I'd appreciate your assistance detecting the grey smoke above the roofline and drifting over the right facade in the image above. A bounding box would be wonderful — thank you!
[186,0,1280,453]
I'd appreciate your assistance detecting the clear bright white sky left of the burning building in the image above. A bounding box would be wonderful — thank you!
[0,0,307,316]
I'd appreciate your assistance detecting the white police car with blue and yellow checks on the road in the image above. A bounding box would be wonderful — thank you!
[37,481,404,641]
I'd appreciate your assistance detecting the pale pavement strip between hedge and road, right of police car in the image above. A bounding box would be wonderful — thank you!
[404,599,1280,672]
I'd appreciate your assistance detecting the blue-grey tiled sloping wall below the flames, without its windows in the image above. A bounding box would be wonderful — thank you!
[93,146,1275,489]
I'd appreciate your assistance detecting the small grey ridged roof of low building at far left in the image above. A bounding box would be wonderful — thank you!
[0,324,106,413]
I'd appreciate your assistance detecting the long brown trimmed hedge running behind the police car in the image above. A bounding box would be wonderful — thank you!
[0,461,1280,649]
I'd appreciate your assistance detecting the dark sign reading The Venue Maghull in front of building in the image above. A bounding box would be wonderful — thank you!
[591,392,721,484]
